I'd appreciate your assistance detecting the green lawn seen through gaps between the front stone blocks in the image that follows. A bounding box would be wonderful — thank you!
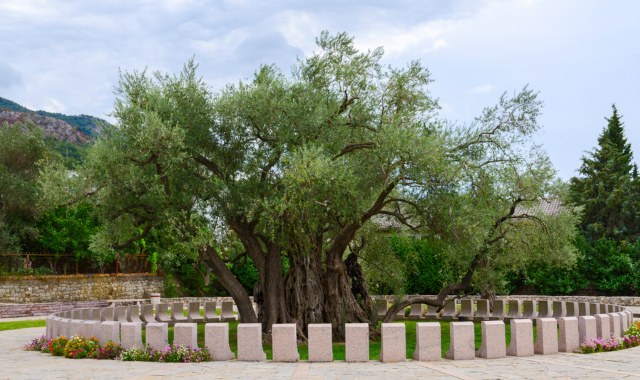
[148,321,536,360]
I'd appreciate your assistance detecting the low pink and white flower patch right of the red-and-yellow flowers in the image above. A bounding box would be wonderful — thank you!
[120,344,211,363]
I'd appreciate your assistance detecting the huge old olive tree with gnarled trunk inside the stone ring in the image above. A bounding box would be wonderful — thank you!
[47,32,576,337]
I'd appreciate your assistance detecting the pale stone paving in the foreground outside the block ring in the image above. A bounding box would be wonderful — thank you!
[0,328,640,380]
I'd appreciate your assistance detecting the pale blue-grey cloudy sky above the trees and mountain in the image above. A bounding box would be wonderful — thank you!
[0,0,640,179]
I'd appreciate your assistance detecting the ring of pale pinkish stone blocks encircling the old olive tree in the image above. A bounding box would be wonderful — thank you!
[46,299,633,362]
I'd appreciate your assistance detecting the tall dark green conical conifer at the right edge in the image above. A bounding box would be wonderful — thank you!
[570,105,640,241]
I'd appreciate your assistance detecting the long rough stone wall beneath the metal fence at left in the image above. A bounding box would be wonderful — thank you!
[0,274,163,304]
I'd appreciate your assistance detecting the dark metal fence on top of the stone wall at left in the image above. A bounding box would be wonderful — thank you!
[0,252,151,275]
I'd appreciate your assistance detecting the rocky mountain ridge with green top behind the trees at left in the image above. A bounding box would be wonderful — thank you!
[0,97,109,144]
